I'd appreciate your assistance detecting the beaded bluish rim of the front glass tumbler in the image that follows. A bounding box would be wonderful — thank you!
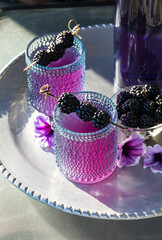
[53,91,117,137]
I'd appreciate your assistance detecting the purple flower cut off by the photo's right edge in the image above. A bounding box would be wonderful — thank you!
[143,144,162,173]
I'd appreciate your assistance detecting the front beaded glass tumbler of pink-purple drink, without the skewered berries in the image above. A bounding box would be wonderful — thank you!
[54,92,118,183]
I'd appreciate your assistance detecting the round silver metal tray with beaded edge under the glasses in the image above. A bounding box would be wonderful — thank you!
[0,25,162,220]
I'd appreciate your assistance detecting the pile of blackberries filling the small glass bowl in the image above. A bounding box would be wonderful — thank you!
[116,84,162,128]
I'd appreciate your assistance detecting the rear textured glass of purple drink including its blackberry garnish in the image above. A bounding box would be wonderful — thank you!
[26,23,85,117]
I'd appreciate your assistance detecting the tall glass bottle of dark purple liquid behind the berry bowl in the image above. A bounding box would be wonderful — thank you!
[114,0,162,89]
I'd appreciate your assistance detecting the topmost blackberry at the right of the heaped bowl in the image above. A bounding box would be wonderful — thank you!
[143,83,161,100]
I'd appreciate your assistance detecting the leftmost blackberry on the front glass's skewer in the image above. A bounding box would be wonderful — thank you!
[57,92,79,114]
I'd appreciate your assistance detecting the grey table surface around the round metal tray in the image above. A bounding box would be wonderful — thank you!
[0,6,162,240]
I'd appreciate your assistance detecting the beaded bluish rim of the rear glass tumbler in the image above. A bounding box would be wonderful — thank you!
[25,32,85,70]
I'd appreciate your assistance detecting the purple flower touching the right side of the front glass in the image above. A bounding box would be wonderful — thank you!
[117,133,146,167]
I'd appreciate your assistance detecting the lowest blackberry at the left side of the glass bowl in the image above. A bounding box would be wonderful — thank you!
[120,111,139,128]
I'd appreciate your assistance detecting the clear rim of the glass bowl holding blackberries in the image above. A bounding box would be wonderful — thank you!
[111,84,162,132]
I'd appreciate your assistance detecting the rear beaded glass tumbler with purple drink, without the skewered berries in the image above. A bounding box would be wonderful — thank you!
[25,34,85,117]
